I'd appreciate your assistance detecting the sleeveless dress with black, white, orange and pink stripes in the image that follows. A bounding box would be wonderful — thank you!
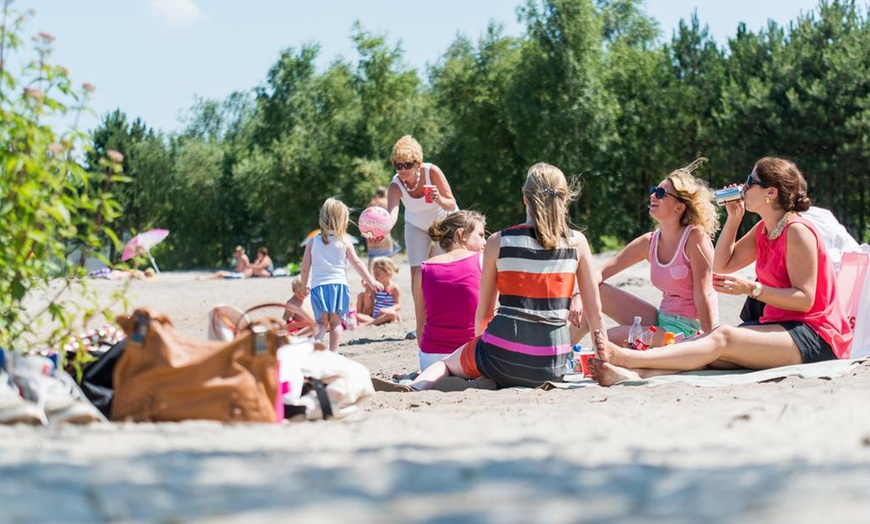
[475,225,577,387]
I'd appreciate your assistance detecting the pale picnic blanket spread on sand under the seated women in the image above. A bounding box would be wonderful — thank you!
[541,358,868,391]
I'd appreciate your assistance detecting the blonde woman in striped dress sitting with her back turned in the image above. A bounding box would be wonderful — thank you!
[379,163,604,390]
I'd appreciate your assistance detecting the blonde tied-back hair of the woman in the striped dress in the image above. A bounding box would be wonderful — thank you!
[523,162,580,249]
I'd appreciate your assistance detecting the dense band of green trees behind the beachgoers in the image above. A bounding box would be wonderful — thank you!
[87,0,870,267]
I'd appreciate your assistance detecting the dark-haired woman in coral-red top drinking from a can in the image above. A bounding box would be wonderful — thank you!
[592,157,852,386]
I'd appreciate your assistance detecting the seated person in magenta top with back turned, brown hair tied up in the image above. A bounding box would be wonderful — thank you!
[414,211,486,369]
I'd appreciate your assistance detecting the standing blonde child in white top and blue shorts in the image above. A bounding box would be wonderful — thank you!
[300,198,384,351]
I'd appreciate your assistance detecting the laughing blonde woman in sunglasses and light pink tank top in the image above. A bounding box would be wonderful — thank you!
[570,158,719,346]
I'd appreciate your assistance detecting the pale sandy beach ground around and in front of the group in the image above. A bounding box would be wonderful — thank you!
[0,255,870,523]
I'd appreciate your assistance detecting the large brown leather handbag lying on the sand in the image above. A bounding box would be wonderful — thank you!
[112,309,286,422]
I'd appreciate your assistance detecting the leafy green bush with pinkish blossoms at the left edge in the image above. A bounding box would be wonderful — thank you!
[0,0,123,349]
